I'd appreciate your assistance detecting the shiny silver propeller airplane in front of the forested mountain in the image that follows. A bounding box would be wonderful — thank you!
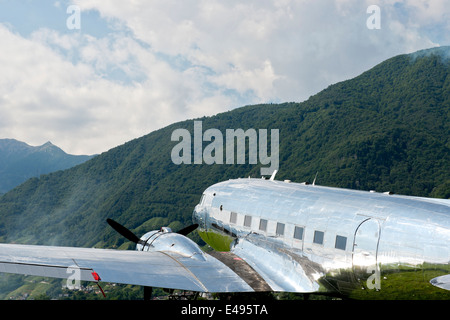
[0,172,450,299]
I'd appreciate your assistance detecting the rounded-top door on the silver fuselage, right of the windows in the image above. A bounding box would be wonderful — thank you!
[353,219,380,290]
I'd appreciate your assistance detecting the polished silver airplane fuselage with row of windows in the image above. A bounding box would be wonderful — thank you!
[193,179,450,299]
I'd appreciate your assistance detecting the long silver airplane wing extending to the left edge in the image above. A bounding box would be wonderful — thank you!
[0,244,254,292]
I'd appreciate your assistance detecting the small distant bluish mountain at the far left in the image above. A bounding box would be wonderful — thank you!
[0,139,92,194]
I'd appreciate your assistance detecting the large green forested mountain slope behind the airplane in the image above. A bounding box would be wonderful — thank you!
[0,47,450,264]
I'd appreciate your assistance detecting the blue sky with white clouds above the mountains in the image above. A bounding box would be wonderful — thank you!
[0,0,450,154]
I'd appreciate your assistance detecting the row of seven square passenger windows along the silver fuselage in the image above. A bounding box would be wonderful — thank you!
[230,211,347,250]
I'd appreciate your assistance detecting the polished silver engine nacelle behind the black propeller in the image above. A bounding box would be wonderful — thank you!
[136,227,206,260]
